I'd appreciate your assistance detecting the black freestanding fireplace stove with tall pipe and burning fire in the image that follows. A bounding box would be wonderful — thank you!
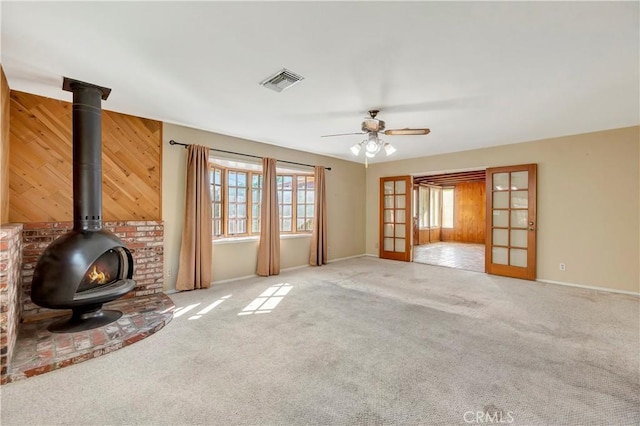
[31,77,135,333]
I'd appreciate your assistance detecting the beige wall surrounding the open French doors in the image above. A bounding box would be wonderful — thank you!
[366,127,640,292]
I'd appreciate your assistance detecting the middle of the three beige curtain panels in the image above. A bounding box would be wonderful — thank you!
[256,158,280,277]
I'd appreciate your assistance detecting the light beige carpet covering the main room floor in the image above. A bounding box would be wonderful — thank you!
[0,258,640,425]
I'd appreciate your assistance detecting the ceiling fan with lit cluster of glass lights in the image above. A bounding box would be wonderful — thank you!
[322,109,430,160]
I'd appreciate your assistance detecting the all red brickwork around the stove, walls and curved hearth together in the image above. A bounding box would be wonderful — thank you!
[0,221,173,384]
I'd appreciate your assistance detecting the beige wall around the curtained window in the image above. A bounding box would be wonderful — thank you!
[162,123,365,290]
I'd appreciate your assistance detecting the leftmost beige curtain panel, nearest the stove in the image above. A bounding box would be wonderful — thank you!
[176,145,213,290]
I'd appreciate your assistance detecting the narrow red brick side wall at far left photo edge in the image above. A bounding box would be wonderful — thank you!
[0,224,22,384]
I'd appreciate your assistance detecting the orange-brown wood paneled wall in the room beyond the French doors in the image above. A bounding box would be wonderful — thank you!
[441,182,486,244]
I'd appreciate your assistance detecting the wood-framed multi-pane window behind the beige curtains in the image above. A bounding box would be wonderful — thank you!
[209,161,314,238]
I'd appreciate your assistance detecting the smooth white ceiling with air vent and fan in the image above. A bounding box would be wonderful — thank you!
[0,1,640,162]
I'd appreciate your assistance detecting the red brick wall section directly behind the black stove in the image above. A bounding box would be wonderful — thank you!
[22,221,164,321]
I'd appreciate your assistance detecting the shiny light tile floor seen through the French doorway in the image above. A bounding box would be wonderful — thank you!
[413,242,484,272]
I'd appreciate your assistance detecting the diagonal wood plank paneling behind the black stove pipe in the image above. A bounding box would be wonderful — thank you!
[9,91,162,222]
